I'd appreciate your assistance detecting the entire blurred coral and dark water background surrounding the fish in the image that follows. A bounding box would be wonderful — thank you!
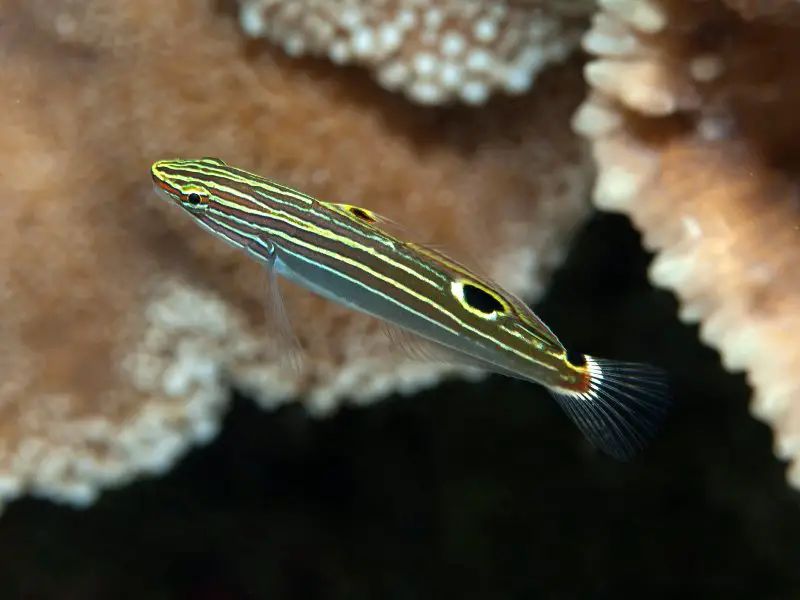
[0,0,800,600]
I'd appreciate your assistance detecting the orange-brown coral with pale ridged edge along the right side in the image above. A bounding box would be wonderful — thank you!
[574,0,800,487]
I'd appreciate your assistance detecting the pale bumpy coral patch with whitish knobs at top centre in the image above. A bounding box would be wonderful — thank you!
[239,0,594,104]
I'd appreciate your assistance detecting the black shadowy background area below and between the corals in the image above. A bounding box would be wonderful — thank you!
[0,215,800,600]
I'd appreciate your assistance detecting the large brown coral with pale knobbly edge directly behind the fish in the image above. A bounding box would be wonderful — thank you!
[0,0,590,510]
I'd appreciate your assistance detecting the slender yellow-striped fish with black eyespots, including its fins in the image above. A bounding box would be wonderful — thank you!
[151,158,670,460]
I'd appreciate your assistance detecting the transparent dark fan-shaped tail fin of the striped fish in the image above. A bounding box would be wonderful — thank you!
[548,356,671,460]
